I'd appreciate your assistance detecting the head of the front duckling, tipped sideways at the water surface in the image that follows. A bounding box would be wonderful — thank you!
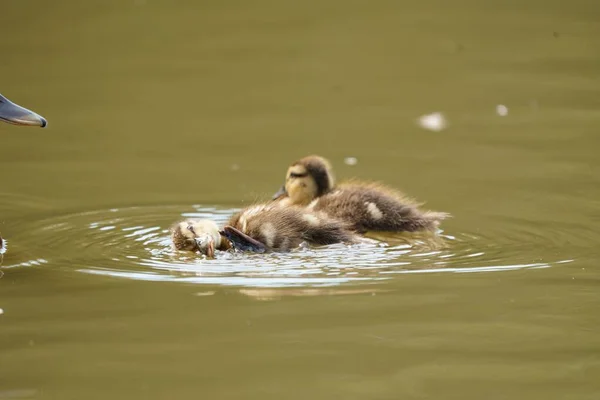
[171,219,223,258]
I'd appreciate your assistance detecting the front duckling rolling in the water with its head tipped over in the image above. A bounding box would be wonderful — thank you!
[172,204,359,257]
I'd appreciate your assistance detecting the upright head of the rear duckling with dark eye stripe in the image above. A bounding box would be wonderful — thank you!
[273,156,335,205]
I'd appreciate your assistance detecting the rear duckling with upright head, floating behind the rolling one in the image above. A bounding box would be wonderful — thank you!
[273,156,450,232]
